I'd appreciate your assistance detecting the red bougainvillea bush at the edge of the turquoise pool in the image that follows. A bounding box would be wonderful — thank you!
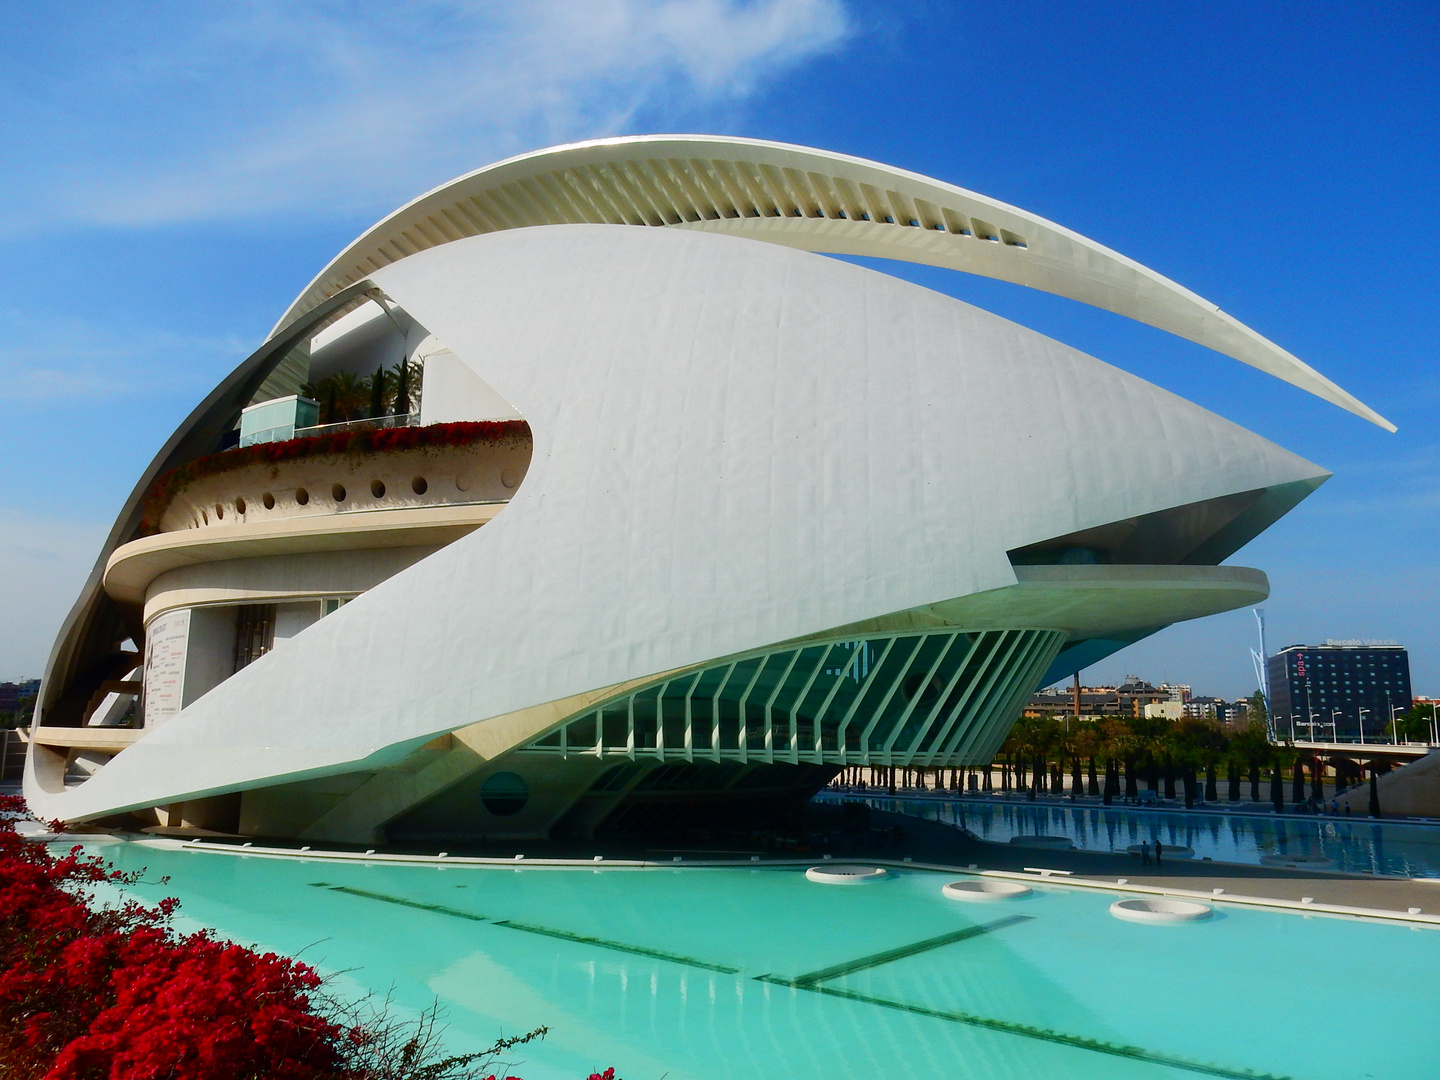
[0,796,615,1080]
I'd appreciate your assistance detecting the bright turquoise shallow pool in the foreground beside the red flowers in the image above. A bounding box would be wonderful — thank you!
[75,841,1440,1080]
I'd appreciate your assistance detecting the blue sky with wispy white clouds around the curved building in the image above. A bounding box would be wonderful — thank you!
[0,0,1440,696]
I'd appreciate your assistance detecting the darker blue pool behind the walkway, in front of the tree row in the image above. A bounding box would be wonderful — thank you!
[840,793,1440,877]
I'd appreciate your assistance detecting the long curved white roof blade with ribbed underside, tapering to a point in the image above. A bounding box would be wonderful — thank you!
[271,134,1397,432]
